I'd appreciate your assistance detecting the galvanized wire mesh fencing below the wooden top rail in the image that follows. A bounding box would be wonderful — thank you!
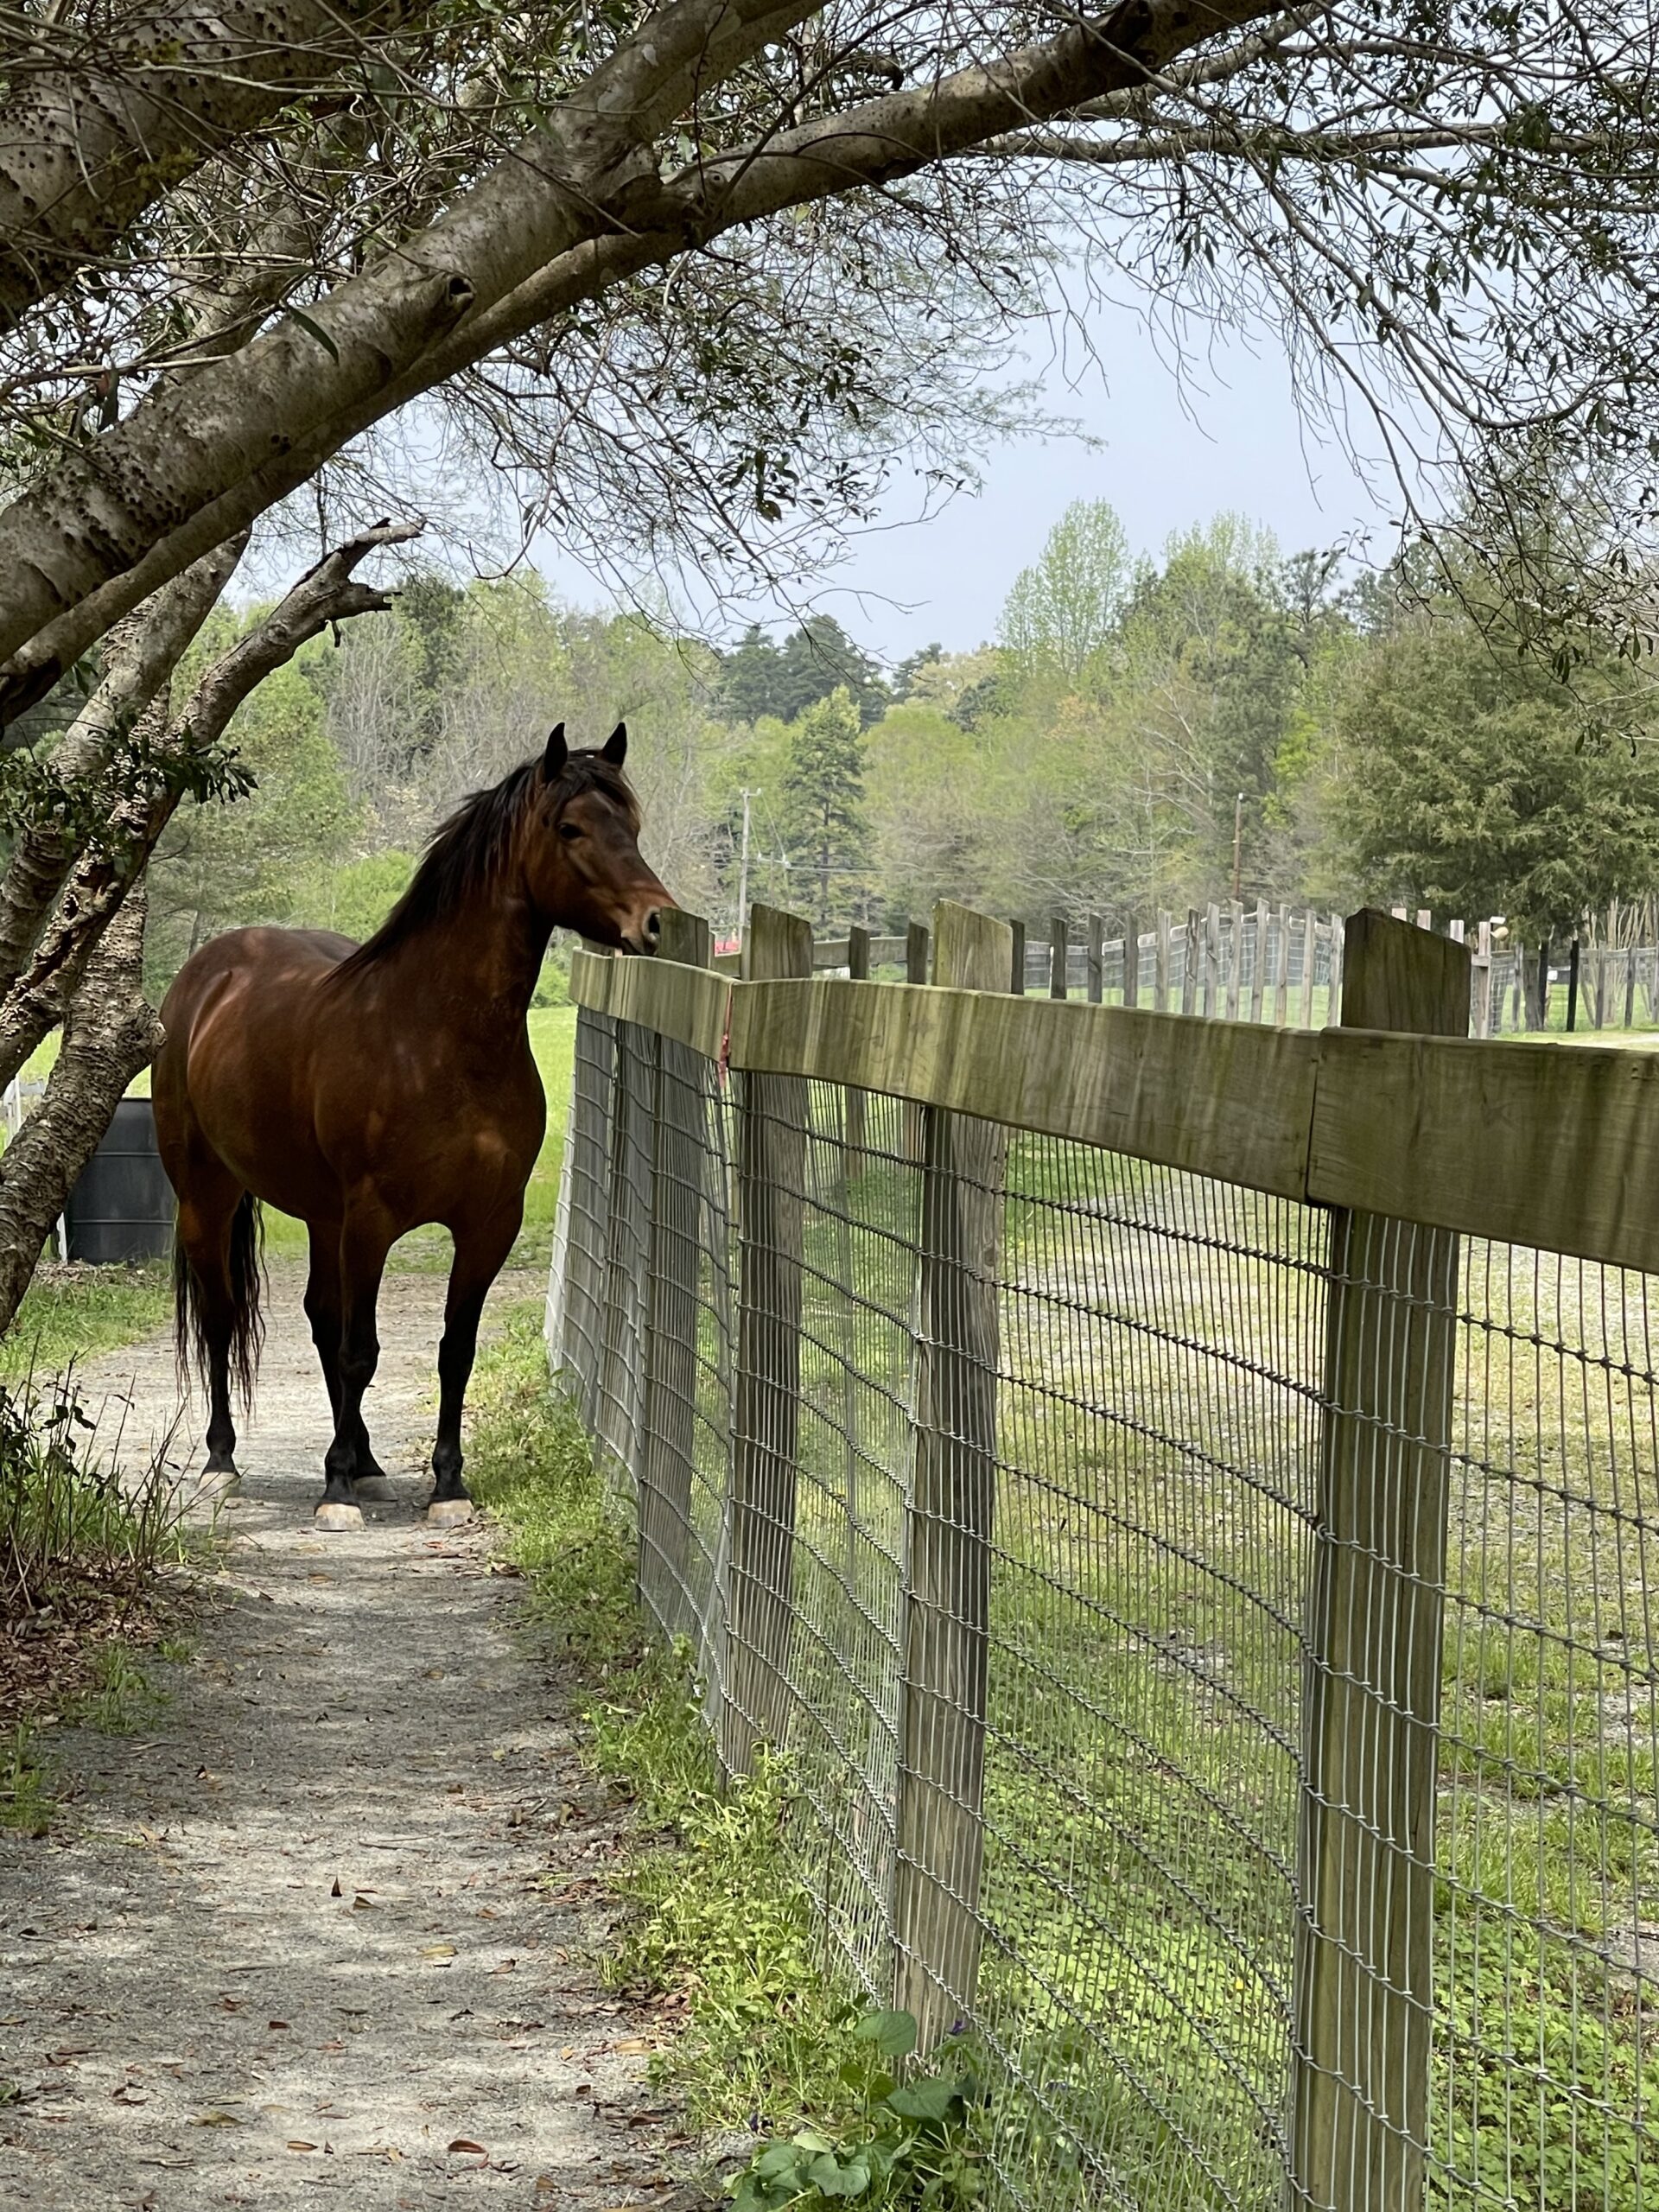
[549,955,1659,2212]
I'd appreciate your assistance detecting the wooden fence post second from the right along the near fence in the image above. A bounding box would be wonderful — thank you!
[893,905,1011,2049]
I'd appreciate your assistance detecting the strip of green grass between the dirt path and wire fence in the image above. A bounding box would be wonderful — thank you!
[467,1305,885,2128]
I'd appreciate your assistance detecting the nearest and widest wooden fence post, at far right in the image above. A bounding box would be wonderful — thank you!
[1287,913,1469,2212]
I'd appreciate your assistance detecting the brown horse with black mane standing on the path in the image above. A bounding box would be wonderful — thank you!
[153,723,672,1529]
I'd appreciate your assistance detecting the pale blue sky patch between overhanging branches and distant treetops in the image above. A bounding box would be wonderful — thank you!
[531,289,1398,664]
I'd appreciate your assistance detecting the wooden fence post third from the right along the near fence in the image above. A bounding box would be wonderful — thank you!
[721,907,812,1774]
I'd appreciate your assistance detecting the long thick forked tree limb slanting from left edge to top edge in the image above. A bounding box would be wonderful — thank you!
[0,0,1269,719]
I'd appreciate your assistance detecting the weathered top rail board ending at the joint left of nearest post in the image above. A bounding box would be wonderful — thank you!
[732,978,1319,1199]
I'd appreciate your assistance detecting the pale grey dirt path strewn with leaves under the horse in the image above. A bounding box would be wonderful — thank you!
[0,1269,681,2212]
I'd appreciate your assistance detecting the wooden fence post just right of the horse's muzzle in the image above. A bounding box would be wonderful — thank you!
[637,907,715,1637]
